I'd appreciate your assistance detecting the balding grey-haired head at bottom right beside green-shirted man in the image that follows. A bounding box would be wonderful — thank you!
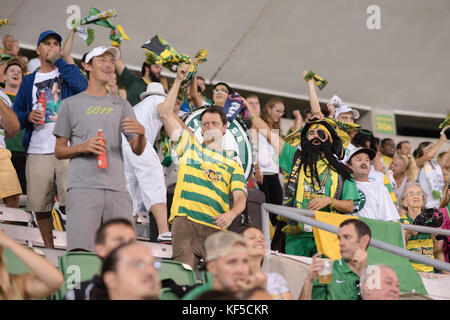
[360,264,400,300]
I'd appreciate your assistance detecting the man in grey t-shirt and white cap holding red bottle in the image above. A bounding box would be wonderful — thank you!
[53,47,146,251]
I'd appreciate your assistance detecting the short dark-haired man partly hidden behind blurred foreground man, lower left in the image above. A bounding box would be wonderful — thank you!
[64,218,136,300]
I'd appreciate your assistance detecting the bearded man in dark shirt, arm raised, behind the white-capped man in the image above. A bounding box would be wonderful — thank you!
[116,33,167,107]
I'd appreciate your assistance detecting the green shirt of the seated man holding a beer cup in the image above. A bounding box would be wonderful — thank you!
[312,259,359,300]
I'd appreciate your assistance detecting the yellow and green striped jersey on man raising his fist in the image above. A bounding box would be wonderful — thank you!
[169,130,247,229]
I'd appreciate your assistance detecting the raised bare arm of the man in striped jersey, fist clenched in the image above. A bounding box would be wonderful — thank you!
[158,63,189,141]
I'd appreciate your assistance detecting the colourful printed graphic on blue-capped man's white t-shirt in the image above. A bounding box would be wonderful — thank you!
[33,74,62,123]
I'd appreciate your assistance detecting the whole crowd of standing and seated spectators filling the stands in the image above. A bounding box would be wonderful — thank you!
[0,23,450,300]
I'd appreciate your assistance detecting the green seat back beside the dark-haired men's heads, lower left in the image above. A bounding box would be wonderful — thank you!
[55,252,102,300]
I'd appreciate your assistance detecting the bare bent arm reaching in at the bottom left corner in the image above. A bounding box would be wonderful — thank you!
[0,230,64,299]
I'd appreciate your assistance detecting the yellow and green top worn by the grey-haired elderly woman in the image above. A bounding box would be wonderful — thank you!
[399,213,434,272]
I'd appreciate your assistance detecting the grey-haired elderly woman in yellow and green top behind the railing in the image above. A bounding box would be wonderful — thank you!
[400,183,445,272]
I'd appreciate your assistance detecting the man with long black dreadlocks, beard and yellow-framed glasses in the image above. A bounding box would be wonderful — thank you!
[249,104,360,257]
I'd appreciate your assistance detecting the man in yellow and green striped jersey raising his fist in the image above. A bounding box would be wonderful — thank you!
[158,72,247,268]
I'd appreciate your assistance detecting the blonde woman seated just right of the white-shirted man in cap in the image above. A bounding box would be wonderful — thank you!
[386,155,418,204]
